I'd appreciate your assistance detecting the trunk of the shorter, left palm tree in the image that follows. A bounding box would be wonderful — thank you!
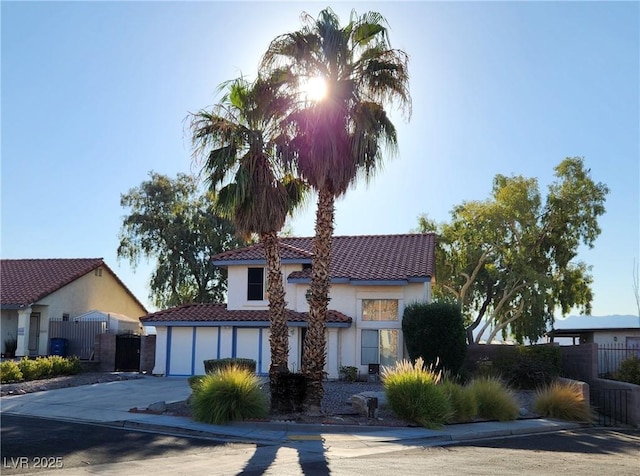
[260,231,291,413]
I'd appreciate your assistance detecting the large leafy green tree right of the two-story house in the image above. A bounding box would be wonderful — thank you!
[418,157,609,343]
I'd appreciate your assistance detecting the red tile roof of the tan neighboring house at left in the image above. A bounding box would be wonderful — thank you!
[0,258,145,309]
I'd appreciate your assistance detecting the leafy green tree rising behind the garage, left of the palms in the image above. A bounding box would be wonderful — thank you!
[118,172,245,308]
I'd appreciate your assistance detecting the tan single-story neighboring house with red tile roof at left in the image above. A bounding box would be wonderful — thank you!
[0,258,147,357]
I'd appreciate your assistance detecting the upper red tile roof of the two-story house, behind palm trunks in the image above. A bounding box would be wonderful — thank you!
[213,233,435,281]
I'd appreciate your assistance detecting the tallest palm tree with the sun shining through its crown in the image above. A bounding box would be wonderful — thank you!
[261,8,411,411]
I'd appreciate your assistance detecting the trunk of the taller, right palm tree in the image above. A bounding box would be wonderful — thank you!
[302,189,335,413]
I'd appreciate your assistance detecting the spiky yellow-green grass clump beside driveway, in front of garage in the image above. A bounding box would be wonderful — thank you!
[191,365,268,425]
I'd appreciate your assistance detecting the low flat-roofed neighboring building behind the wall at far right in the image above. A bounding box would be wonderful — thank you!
[548,316,640,348]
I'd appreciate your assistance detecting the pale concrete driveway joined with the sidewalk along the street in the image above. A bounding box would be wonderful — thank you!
[0,376,580,448]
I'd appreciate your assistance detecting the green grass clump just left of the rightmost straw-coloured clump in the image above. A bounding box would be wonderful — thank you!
[468,377,520,421]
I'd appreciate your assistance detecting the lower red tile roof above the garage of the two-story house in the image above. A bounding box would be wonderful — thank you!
[140,304,351,325]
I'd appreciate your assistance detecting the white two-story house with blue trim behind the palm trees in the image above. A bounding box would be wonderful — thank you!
[141,233,435,378]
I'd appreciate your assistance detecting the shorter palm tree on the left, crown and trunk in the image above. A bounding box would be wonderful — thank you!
[191,78,306,412]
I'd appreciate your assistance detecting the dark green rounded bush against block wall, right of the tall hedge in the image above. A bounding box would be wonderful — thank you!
[494,345,562,389]
